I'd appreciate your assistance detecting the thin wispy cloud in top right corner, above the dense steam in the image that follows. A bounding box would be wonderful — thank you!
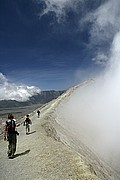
[88,0,120,48]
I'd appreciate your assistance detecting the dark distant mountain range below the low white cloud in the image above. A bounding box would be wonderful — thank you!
[0,90,65,108]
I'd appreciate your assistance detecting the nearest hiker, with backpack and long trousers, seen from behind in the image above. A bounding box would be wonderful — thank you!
[4,113,19,158]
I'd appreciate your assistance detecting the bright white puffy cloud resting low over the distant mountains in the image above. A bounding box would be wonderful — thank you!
[0,73,41,101]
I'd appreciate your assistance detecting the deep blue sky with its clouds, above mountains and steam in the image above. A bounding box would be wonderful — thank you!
[0,0,120,101]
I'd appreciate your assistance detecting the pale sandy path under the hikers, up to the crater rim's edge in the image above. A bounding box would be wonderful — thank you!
[0,97,98,180]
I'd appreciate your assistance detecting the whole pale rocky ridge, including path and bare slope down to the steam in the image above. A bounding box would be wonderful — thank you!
[0,84,120,180]
